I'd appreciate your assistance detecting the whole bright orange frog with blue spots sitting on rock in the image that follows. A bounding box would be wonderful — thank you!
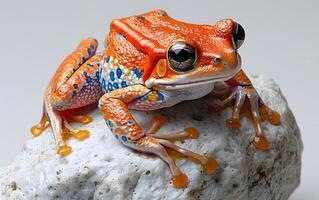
[31,10,280,188]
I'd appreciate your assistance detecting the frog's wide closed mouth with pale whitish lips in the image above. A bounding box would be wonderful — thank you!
[145,55,241,90]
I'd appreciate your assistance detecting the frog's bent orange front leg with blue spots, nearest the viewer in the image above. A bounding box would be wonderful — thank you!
[99,85,217,188]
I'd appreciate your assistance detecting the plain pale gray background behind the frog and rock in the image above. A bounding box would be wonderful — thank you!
[0,0,319,200]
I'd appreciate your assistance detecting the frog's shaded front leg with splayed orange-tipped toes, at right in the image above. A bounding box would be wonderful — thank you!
[209,70,280,150]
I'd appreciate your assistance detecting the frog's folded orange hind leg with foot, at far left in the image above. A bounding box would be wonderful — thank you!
[31,38,103,156]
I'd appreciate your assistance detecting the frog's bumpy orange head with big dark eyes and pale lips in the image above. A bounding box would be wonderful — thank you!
[145,19,245,90]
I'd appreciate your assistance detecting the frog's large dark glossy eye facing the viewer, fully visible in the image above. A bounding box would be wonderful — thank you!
[167,42,197,72]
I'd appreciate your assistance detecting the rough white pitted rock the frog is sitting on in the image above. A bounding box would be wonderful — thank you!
[0,77,303,200]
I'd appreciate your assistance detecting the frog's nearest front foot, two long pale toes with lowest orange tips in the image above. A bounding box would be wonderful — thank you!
[137,136,218,188]
